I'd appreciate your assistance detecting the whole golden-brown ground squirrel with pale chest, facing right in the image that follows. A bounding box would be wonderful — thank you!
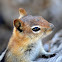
[0,8,54,62]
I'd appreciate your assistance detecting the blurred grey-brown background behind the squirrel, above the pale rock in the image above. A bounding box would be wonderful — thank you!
[0,0,62,52]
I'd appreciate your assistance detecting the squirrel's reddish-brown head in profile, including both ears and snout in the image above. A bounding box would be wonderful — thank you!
[13,8,54,39]
